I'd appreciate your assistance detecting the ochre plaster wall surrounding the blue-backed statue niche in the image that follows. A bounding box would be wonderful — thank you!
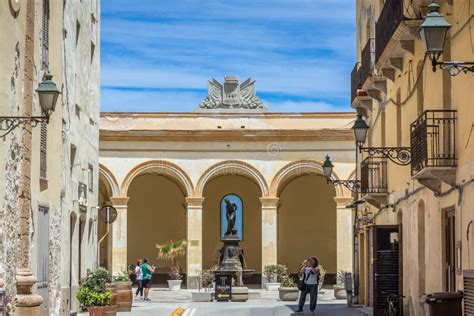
[202,175,262,271]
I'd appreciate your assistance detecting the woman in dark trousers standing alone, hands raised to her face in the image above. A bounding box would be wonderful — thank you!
[296,257,319,313]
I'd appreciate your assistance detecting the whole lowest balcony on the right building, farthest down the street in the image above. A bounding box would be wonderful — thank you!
[360,157,388,207]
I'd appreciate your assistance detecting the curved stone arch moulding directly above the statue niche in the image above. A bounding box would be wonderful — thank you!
[195,160,268,197]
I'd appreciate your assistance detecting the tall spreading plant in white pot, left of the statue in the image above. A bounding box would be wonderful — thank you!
[156,240,187,291]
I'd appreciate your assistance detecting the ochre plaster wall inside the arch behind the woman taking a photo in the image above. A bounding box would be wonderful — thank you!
[278,175,337,273]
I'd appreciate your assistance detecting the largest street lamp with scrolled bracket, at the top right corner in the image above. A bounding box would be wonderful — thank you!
[421,1,474,76]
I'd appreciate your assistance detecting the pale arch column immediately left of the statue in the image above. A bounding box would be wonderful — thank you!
[186,197,204,289]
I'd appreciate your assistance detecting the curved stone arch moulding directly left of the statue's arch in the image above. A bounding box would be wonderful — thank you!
[120,160,194,196]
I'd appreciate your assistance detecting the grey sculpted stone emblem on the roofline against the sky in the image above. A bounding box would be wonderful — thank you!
[198,76,267,110]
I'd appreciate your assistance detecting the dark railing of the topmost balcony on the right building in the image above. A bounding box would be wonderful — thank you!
[375,0,404,61]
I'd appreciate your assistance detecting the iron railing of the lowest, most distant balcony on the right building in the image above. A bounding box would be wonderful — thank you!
[360,157,388,194]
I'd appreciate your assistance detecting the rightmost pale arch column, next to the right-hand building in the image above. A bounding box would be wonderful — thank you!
[334,197,353,271]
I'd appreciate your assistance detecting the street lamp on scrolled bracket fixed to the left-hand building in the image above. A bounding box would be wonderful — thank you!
[0,72,60,138]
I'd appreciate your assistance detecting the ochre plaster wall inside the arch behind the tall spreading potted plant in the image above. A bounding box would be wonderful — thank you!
[127,175,186,273]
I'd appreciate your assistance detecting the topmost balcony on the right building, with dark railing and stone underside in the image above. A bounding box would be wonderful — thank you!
[375,0,423,71]
